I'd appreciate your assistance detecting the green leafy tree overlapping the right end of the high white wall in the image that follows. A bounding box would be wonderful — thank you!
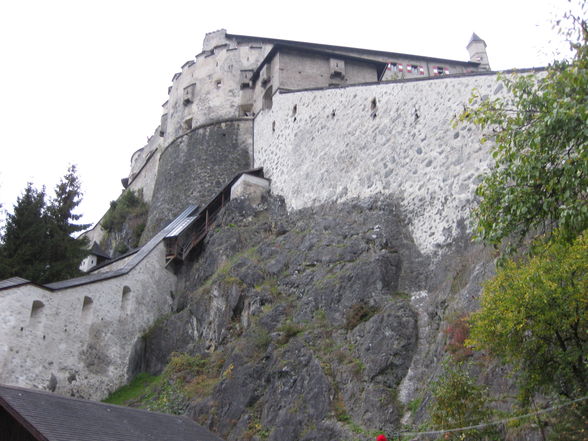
[460,2,588,251]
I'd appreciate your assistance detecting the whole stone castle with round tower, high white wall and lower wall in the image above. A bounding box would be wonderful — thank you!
[0,30,504,399]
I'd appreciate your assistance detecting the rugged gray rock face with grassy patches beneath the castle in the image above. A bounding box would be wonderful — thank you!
[137,197,496,441]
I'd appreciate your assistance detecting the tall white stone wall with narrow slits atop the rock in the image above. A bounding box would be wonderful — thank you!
[254,75,504,254]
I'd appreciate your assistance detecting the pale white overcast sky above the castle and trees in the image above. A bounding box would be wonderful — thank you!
[0,0,568,227]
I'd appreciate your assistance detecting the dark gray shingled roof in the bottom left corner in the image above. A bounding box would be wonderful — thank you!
[0,385,222,441]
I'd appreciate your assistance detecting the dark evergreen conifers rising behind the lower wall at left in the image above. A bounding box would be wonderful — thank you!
[0,166,88,284]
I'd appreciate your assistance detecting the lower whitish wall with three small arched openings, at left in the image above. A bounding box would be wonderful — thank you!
[0,243,175,399]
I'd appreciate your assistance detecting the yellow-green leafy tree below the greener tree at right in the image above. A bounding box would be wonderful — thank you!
[469,230,588,397]
